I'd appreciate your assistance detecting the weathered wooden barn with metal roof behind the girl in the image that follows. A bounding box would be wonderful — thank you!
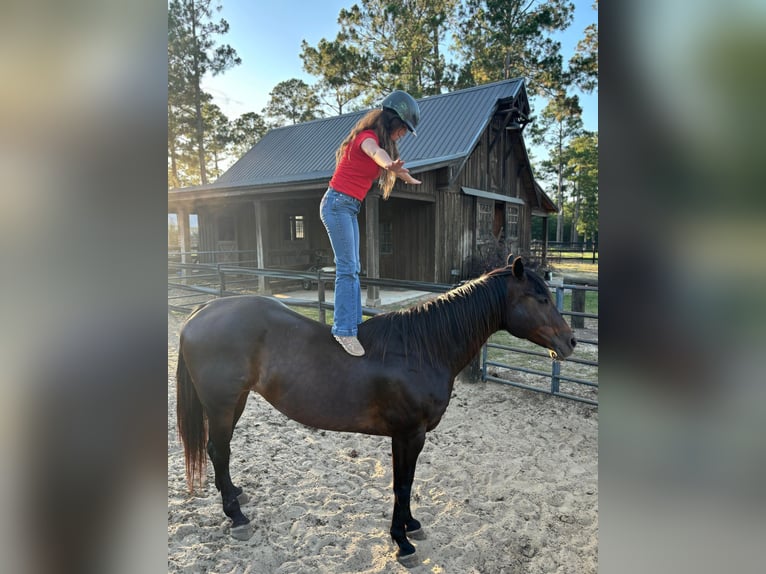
[168,79,557,290]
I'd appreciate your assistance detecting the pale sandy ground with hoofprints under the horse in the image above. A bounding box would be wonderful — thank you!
[168,313,598,574]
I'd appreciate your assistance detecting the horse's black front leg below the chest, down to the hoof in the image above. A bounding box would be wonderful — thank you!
[391,429,426,568]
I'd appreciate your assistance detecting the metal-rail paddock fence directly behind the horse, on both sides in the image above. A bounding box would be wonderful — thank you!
[168,252,598,405]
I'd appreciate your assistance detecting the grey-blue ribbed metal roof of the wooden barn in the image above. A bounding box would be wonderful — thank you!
[184,79,529,191]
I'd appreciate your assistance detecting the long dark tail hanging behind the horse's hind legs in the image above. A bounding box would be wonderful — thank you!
[176,351,207,492]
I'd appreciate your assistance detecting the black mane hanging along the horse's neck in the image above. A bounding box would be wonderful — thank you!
[359,268,511,365]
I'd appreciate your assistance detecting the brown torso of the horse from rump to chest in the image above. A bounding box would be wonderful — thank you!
[181,296,450,436]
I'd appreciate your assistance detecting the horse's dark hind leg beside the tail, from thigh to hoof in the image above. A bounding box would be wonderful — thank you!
[207,403,253,540]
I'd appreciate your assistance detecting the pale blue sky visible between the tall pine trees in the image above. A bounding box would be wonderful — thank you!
[203,0,598,135]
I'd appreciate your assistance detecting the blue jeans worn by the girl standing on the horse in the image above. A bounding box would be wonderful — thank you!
[319,187,362,337]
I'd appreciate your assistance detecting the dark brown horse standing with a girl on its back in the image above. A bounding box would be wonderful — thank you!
[176,258,576,566]
